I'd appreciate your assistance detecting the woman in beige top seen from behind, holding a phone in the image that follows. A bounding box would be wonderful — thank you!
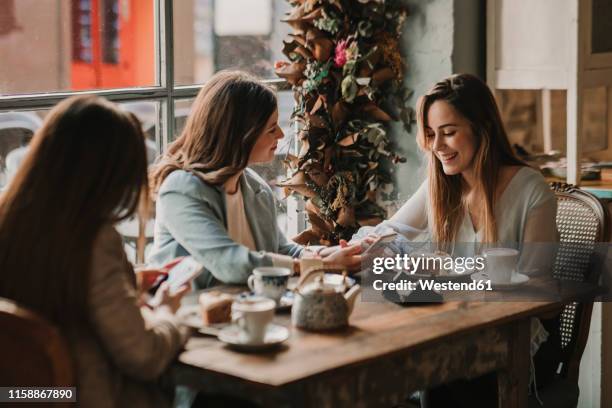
[0,96,187,407]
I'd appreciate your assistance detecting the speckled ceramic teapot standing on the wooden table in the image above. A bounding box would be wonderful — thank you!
[291,270,361,330]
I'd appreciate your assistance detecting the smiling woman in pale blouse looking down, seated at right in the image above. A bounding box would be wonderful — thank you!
[386,74,560,407]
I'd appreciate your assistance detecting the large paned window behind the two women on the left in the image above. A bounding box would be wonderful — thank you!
[0,0,293,262]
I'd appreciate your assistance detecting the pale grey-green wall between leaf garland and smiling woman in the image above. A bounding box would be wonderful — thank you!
[392,0,486,201]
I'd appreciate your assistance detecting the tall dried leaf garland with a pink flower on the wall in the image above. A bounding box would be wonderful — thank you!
[276,0,413,245]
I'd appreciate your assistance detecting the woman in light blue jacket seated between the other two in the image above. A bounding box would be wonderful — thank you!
[150,71,360,287]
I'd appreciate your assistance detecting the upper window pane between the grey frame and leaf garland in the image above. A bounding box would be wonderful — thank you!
[174,0,290,85]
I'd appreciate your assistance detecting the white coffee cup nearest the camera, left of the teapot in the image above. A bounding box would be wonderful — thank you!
[232,296,276,344]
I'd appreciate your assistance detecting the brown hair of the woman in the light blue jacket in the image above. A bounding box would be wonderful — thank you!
[151,71,277,192]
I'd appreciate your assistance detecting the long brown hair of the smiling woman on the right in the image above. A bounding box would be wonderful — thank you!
[417,74,526,245]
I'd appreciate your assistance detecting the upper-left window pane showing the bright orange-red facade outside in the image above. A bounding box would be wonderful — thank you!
[0,0,155,94]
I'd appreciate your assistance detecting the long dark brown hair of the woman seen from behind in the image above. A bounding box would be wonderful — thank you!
[0,96,147,327]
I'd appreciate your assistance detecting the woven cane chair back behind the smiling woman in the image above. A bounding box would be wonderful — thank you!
[551,183,608,381]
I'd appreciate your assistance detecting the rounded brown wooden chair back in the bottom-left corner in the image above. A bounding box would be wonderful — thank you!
[0,298,74,387]
